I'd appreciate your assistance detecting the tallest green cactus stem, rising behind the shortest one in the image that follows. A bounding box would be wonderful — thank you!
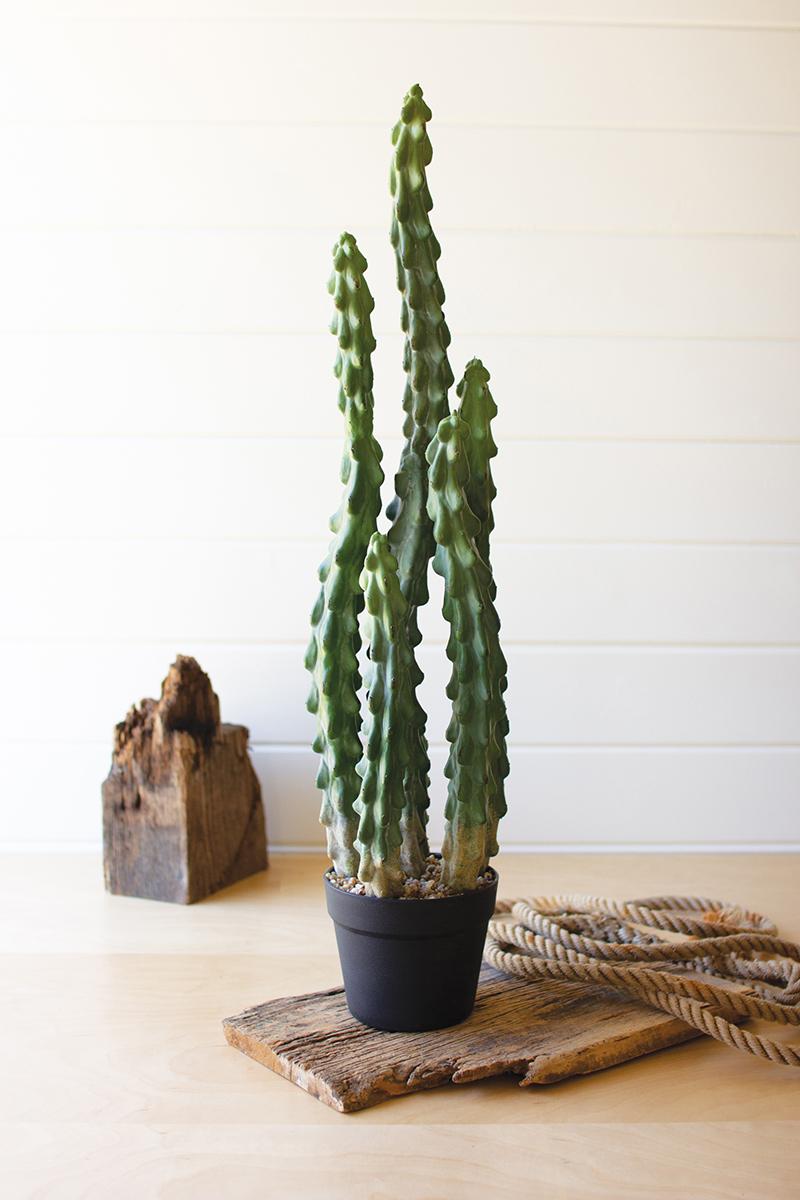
[386,84,453,646]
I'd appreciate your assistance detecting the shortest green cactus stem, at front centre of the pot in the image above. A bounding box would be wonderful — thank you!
[355,533,427,896]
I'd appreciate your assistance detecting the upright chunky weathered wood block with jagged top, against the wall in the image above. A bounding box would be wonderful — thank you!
[103,655,266,904]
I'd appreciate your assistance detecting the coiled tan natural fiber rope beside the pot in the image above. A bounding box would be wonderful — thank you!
[485,895,800,1067]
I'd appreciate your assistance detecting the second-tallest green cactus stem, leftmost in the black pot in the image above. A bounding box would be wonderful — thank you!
[306,233,384,876]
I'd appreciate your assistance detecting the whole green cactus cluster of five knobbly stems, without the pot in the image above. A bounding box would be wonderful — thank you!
[306,85,509,898]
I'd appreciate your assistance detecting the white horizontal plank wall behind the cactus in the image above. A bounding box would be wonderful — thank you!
[0,0,800,846]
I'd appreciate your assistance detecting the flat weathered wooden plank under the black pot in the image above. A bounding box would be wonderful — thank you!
[223,965,699,1112]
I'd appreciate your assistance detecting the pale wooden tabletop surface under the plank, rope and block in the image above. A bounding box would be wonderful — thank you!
[0,854,800,1200]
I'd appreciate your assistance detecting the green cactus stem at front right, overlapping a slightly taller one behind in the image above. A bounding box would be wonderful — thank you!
[427,413,507,892]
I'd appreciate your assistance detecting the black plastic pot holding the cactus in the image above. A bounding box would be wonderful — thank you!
[325,872,498,1032]
